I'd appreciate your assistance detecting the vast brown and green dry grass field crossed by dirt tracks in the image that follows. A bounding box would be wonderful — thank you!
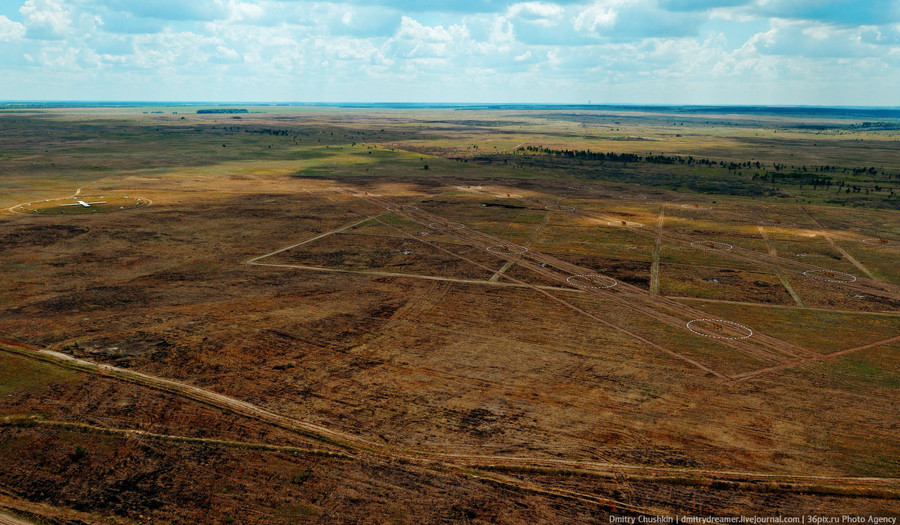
[0,108,900,523]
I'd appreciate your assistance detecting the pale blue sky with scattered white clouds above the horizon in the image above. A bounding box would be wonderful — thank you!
[0,0,900,106]
